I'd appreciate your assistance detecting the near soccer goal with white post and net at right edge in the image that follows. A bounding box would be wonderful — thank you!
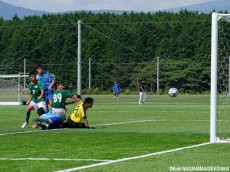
[210,12,230,143]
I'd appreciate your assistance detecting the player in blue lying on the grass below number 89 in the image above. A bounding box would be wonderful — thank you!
[33,107,63,130]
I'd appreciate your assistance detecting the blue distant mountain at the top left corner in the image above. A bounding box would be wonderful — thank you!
[0,1,48,20]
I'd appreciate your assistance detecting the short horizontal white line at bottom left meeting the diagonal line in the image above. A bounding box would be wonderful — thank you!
[0,158,111,162]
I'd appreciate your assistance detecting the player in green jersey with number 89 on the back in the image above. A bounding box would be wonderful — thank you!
[52,82,81,121]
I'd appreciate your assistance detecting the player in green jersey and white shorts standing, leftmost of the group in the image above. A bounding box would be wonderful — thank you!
[22,72,46,128]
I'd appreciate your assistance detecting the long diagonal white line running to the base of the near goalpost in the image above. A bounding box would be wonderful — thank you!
[55,142,211,172]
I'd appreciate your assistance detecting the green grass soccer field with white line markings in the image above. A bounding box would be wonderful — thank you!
[0,95,230,172]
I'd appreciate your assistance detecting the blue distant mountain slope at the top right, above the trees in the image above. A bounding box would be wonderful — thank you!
[165,0,230,13]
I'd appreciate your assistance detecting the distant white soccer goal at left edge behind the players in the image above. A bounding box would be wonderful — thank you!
[0,74,28,105]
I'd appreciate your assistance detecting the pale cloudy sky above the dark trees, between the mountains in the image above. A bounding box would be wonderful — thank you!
[1,0,213,12]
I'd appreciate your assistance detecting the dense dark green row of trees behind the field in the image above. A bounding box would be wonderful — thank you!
[0,10,211,93]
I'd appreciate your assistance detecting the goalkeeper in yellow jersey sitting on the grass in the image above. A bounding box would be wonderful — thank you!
[64,97,94,128]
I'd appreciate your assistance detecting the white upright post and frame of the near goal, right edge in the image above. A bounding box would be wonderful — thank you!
[210,12,230,143]
